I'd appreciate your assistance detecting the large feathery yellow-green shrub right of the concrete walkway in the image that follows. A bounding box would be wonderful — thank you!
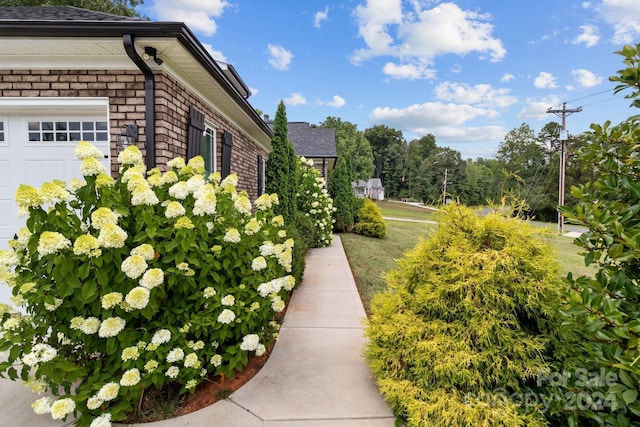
[366,204,560,427]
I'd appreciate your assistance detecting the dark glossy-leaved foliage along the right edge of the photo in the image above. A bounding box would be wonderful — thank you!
[561,44,640,426]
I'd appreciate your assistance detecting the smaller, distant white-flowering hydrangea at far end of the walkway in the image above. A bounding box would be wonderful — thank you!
[296,157,334,248]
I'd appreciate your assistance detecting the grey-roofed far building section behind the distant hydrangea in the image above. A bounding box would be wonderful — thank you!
[269,122,338,181]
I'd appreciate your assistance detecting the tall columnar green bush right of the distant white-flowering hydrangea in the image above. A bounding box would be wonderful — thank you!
[329,157,356,233]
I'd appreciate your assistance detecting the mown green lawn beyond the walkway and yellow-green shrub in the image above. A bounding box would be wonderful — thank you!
[340,201,596,312]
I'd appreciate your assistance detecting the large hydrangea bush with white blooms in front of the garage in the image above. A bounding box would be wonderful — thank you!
[0,142,296,426]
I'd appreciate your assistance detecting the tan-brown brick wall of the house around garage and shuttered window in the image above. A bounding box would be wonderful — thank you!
[0,70,267,198]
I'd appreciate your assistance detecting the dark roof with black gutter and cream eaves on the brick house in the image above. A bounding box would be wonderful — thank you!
[0,6,273,150]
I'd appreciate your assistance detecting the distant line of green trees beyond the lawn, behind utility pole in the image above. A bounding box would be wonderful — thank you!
[317,117,593,221]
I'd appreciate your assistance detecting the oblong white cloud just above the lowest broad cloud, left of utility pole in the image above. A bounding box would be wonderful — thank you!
[435,82,518,108]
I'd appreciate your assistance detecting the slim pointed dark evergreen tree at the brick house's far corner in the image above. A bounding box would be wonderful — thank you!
[266,101,297,224]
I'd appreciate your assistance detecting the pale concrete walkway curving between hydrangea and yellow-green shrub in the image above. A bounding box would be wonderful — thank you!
[0,236,395,427]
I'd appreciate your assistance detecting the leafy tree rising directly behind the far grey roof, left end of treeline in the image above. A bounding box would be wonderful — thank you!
[320,117,374,180]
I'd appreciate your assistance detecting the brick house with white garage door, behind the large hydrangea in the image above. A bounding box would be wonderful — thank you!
[0,6,273,254]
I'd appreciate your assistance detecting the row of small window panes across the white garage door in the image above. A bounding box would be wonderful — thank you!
[28,121,109,142]
